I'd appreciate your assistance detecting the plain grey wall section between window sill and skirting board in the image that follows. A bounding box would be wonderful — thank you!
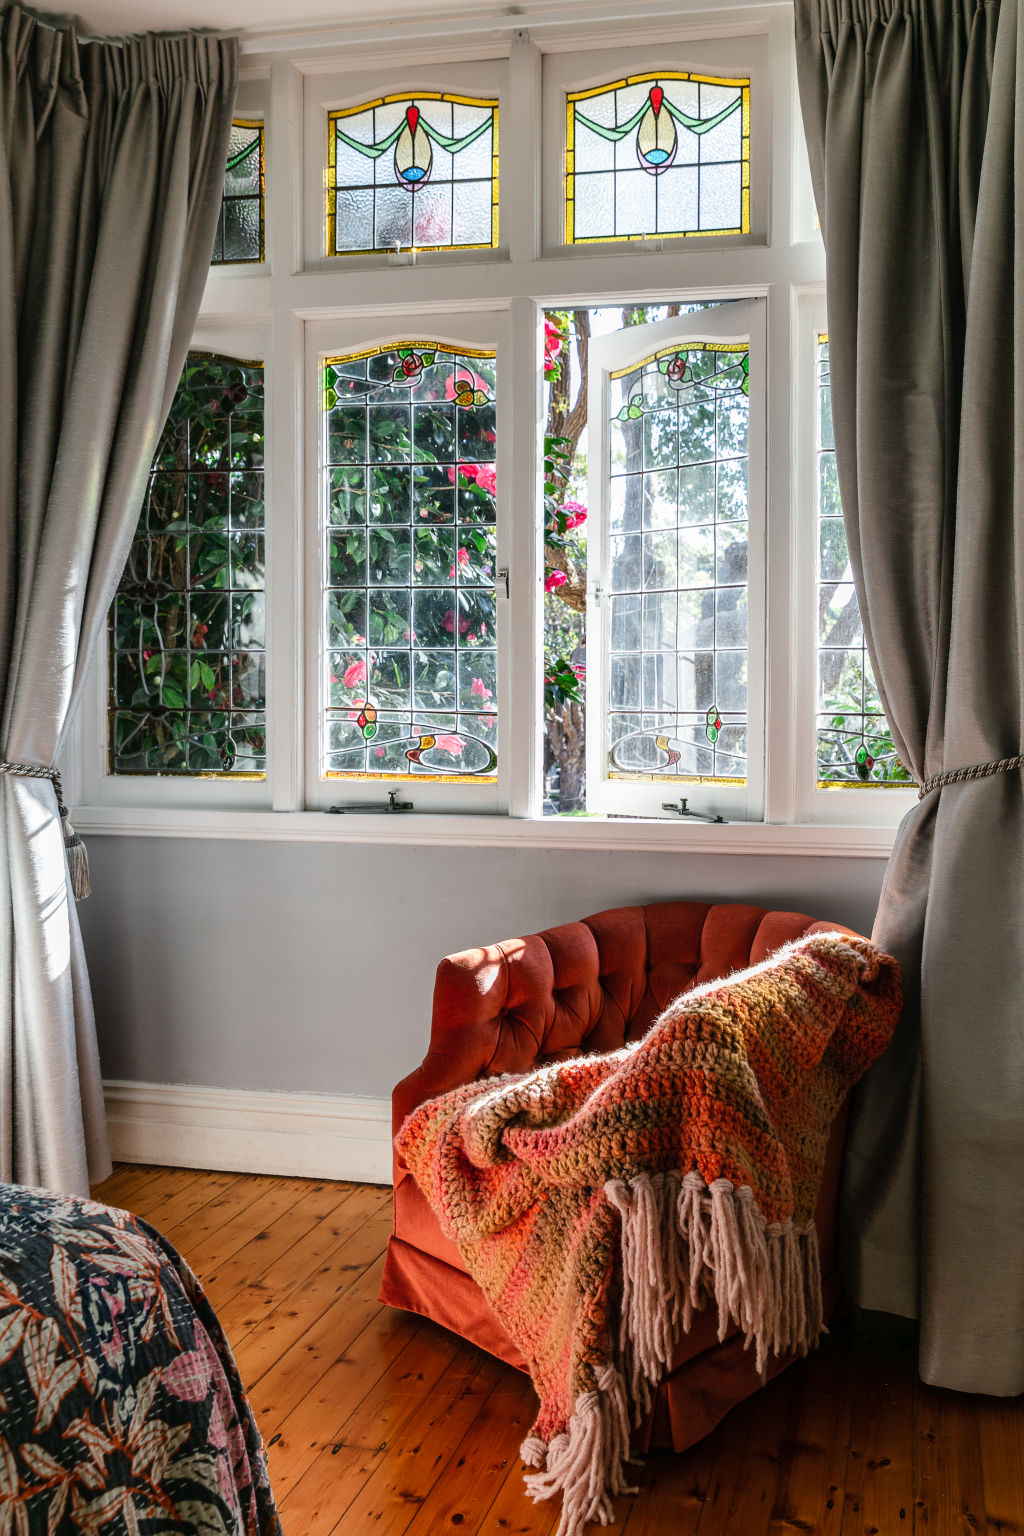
[78,836,884,1098]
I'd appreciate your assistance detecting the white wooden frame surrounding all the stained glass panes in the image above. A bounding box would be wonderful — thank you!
[64,0,898,857]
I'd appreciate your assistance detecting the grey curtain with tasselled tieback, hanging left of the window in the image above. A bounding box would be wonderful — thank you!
[0,5,236,1192]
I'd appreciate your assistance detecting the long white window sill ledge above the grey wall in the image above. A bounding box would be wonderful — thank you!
[72,806,897,859]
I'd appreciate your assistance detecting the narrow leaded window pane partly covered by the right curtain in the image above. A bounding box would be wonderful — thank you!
[817,333,912,790]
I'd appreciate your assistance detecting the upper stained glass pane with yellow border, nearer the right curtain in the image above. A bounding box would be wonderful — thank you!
[565,71,751,244]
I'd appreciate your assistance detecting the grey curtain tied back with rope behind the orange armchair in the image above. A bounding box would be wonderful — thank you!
[795,0,1024,1395]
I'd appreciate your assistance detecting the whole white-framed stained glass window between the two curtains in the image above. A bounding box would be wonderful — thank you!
[77,6,912,851]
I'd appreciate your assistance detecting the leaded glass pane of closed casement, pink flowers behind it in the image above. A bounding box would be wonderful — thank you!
[322,341,497,783]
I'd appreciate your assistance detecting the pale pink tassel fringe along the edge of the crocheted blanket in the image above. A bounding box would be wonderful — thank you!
[520,1172,826,1536]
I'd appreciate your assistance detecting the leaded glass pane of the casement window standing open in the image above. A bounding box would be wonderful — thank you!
[606,341,749,783]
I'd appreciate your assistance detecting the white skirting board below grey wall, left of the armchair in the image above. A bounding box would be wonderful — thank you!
[103,1081,391,1184]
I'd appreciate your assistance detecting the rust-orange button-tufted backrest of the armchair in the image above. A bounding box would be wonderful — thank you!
[391,902,849,1148]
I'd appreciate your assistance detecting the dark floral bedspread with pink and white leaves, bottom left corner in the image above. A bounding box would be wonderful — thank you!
[0,1184,281,1536]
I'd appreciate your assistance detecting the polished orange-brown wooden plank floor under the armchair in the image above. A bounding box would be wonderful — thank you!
[95,1166,1024,1536]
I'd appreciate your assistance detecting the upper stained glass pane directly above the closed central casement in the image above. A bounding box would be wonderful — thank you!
[327,91,497,257]
